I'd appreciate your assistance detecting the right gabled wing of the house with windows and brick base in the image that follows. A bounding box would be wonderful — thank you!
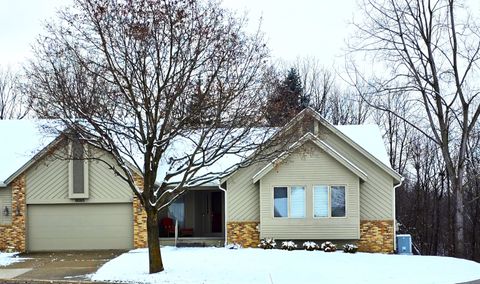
[224,109,402,253]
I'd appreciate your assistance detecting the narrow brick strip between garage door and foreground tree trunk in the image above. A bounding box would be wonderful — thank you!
[133,174,148,248]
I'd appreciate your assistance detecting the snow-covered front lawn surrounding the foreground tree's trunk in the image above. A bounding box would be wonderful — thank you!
[92,247,480,284]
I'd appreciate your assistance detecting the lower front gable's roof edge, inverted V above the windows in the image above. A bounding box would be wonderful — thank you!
[252,132,368,183]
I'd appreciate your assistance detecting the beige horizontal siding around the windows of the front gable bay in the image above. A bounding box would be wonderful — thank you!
[260,143,360,239]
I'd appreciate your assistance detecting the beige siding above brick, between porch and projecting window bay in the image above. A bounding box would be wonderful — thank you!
[226,164,264,222]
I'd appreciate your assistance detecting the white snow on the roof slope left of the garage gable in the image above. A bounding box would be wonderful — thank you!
[0,120,55,187]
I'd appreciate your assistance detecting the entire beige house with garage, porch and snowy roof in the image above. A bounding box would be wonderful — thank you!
[0,109,401,252]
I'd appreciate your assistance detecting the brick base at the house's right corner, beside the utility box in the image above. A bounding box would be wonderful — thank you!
[357,220,394,253]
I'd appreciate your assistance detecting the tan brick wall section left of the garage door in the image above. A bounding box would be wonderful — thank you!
[0,175,27,252]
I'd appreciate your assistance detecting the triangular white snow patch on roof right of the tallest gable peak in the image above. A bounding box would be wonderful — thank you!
[335,124,391,168]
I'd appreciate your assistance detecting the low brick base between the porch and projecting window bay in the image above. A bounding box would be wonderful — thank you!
[227,222,260,247]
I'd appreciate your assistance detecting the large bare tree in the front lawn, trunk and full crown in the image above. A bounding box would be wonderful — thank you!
[27,0,280,273]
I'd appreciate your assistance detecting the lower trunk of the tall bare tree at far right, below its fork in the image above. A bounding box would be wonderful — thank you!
[453,181,465,258]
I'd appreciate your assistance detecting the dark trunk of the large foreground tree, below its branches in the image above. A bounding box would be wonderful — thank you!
[146,209,163,274]
